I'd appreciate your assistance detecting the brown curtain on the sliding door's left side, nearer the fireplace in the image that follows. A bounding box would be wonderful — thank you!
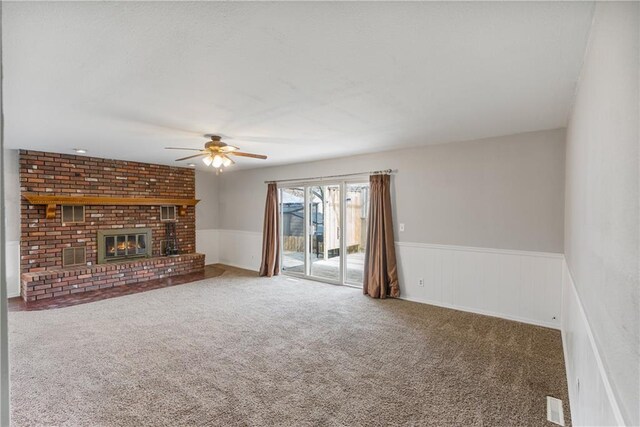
[260,183,280,277]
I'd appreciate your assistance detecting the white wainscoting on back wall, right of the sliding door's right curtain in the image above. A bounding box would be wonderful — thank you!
[396,242,563,329]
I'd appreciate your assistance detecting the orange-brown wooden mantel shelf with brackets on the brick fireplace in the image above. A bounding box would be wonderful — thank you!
[24,193,200,219]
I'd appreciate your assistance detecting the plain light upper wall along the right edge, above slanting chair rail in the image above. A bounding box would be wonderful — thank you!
[565,2,640,425]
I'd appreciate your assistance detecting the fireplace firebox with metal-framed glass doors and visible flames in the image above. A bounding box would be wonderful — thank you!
[98,228,152,264]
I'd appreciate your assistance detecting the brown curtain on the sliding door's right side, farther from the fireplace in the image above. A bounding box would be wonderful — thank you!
[362,175,400,298]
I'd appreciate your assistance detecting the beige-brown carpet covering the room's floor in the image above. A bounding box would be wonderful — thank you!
[9,272,569,426]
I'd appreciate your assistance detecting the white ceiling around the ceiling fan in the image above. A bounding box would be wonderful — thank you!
[2,2,593,171]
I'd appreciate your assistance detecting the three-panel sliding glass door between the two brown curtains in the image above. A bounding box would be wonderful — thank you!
[280,181,369,286]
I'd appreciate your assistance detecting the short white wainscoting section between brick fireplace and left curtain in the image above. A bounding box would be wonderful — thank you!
[218,230,262,271]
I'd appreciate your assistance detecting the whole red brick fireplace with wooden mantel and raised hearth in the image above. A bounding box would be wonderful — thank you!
[20,151,204,301]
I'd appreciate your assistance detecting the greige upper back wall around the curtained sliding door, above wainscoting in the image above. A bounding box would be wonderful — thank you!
[218,129,565,253]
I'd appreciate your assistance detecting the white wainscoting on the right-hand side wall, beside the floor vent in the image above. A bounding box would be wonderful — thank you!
[562,262,625,426]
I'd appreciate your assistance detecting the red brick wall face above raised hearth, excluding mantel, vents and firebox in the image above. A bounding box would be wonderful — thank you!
[20,151,195,273]
